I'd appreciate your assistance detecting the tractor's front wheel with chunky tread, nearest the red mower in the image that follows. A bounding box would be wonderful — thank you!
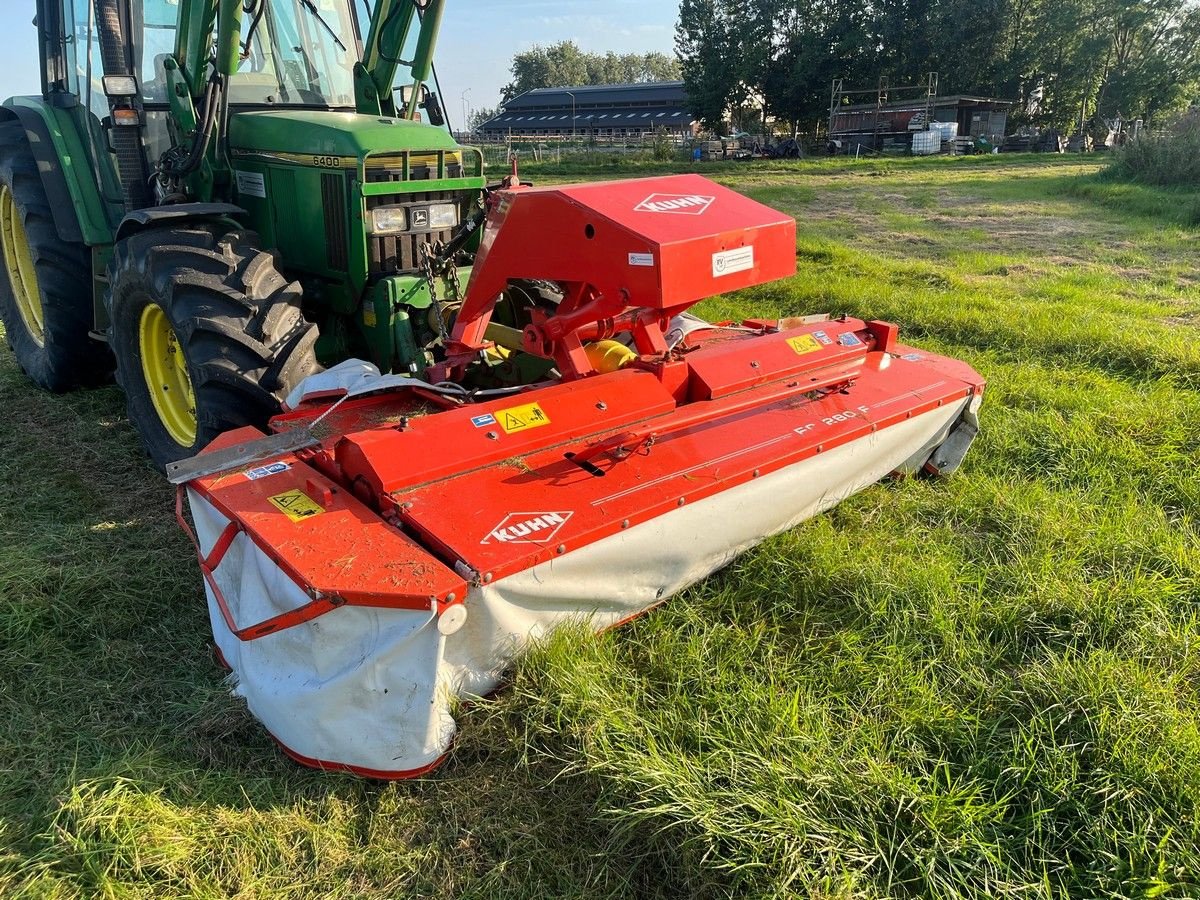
[108,224,320,469]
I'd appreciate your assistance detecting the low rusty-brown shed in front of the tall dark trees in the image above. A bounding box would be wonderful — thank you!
[829,96,1013,146]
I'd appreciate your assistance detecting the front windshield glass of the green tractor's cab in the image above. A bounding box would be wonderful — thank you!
[229,0,359,108]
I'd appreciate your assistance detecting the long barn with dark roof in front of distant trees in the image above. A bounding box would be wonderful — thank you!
[479,82,698,138]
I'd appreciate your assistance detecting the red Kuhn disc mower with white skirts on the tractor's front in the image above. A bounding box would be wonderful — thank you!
[170,176,984,778]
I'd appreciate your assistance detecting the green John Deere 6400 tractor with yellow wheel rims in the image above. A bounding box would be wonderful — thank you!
[0,0,486,467]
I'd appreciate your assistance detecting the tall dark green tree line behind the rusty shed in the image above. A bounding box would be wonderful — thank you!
[676,0,1200,131]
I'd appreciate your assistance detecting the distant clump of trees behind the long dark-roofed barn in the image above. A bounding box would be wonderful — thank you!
[502,41,679,102]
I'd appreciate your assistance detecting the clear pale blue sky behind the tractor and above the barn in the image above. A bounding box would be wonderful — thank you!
[0,0,679,126]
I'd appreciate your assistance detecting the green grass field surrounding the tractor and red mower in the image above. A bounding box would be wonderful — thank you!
[0,157,1200,898]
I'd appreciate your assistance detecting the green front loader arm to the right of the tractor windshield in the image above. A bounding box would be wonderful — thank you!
[355,0,445,119]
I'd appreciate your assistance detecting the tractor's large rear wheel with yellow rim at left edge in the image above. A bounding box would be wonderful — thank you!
[0,122,113,392]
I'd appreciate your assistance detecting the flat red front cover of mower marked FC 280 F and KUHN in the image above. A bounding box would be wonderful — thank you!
[394,342,982,578]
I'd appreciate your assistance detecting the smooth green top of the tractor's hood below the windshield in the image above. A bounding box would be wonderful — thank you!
[229,109,460,158]
